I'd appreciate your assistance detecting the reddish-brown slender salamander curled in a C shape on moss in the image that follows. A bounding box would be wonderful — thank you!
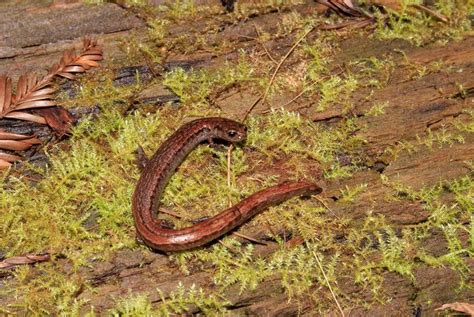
[132,118,321,251]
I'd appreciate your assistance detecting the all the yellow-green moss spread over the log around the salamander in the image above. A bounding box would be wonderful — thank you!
[0,1,474,316]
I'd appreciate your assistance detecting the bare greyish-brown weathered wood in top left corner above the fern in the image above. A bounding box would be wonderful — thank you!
[0,1,143,78]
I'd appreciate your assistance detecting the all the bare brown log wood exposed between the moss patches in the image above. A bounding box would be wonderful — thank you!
[0,1,474,316]
